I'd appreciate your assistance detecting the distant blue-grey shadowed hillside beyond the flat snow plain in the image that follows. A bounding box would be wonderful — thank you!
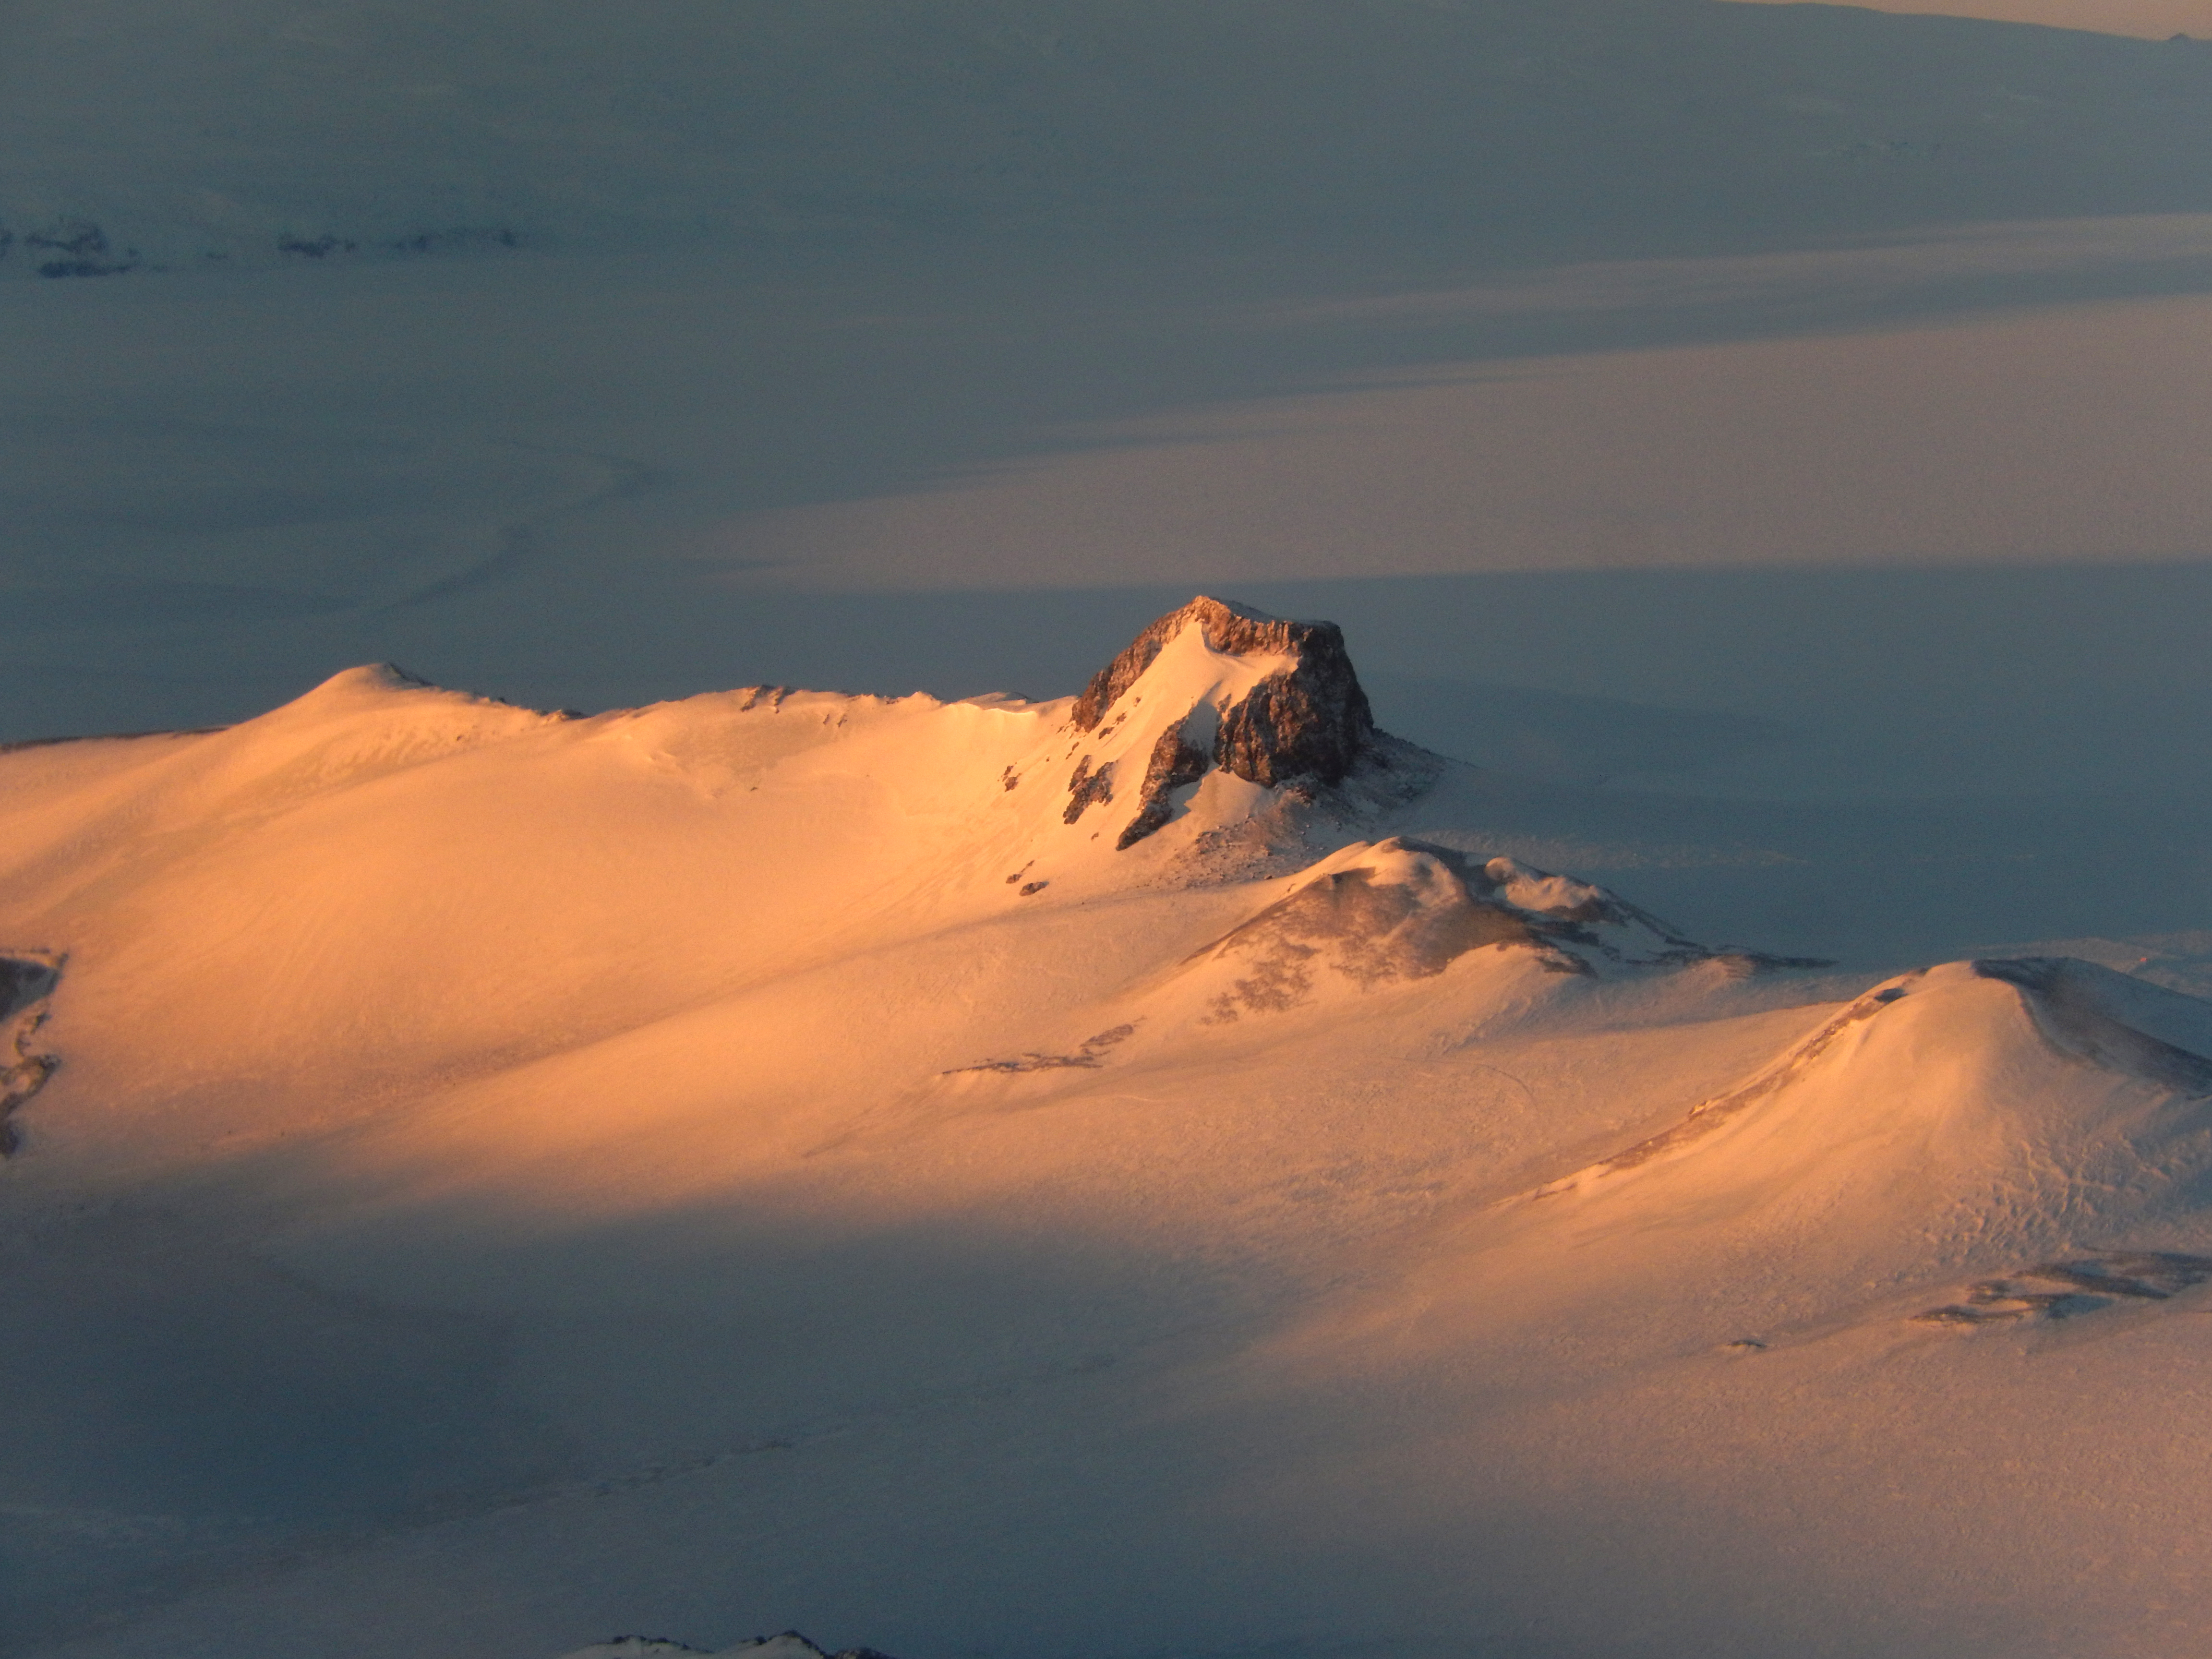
[13,0,2212,276]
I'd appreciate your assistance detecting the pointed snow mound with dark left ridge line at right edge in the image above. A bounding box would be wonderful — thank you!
[1528,958,2212,1254]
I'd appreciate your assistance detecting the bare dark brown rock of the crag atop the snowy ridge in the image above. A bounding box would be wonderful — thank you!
[1069,595,1376,847]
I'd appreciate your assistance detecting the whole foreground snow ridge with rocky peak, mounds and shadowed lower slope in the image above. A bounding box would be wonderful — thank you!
[0,597,2212,1659]
